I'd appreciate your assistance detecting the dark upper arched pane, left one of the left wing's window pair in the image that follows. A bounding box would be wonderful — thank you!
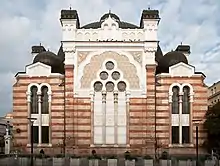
[30,86,38,114]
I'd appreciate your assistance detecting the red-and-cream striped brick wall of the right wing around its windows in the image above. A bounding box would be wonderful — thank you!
[157,76,208,153]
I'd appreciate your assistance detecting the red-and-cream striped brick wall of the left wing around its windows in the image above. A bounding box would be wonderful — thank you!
[13,77,64,150]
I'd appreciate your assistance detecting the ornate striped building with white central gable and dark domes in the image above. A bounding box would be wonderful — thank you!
[13,10,208,154]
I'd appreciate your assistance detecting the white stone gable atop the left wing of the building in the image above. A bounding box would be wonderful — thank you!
[26,62,51,77]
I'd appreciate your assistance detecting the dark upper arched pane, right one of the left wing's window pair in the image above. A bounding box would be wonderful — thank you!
[41,86,49,114]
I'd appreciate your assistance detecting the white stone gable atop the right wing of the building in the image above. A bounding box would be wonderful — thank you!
[169,62,195,77]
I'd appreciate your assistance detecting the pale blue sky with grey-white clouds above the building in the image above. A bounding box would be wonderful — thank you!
[0,0,220,116]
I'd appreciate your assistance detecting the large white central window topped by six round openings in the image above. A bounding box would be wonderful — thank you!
[93,61,127,145]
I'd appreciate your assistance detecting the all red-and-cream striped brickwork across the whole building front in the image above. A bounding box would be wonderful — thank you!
[13,66,207,154]
